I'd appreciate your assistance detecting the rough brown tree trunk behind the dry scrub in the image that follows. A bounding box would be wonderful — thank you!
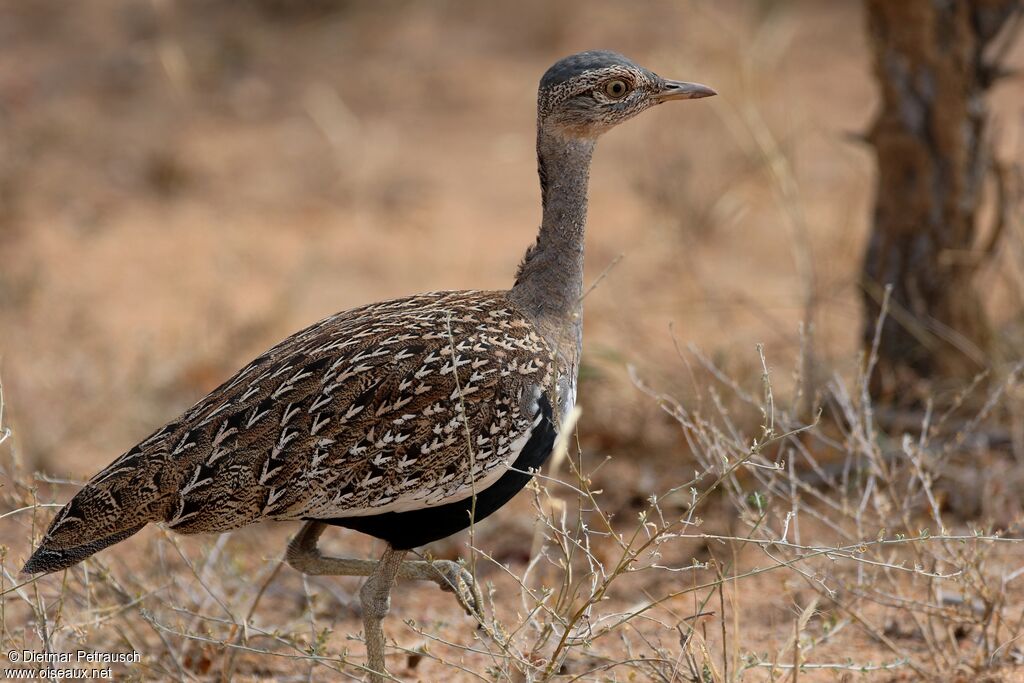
[862,0,1021,402]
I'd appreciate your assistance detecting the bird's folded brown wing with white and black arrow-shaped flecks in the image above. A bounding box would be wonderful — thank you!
[140,292,552,533]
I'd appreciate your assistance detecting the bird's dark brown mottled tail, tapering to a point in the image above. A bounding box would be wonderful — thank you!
[22,452,177,573]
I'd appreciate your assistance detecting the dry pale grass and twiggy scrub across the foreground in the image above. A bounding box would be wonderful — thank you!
[6,337,1024,681]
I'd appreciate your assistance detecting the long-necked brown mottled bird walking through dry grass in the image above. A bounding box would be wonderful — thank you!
[23,50,717,680]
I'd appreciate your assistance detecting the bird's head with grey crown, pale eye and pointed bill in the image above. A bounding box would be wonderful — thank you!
[538,50,717,139]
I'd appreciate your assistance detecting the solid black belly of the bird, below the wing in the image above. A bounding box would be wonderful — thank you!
[319,395,555,550]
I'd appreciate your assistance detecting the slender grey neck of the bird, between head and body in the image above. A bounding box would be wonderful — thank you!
[510,127,594,327]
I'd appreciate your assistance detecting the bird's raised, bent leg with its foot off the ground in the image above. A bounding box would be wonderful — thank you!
[285,520,483,618]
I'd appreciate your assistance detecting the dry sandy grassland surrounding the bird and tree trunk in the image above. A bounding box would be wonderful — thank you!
[0,0,1024,681]
